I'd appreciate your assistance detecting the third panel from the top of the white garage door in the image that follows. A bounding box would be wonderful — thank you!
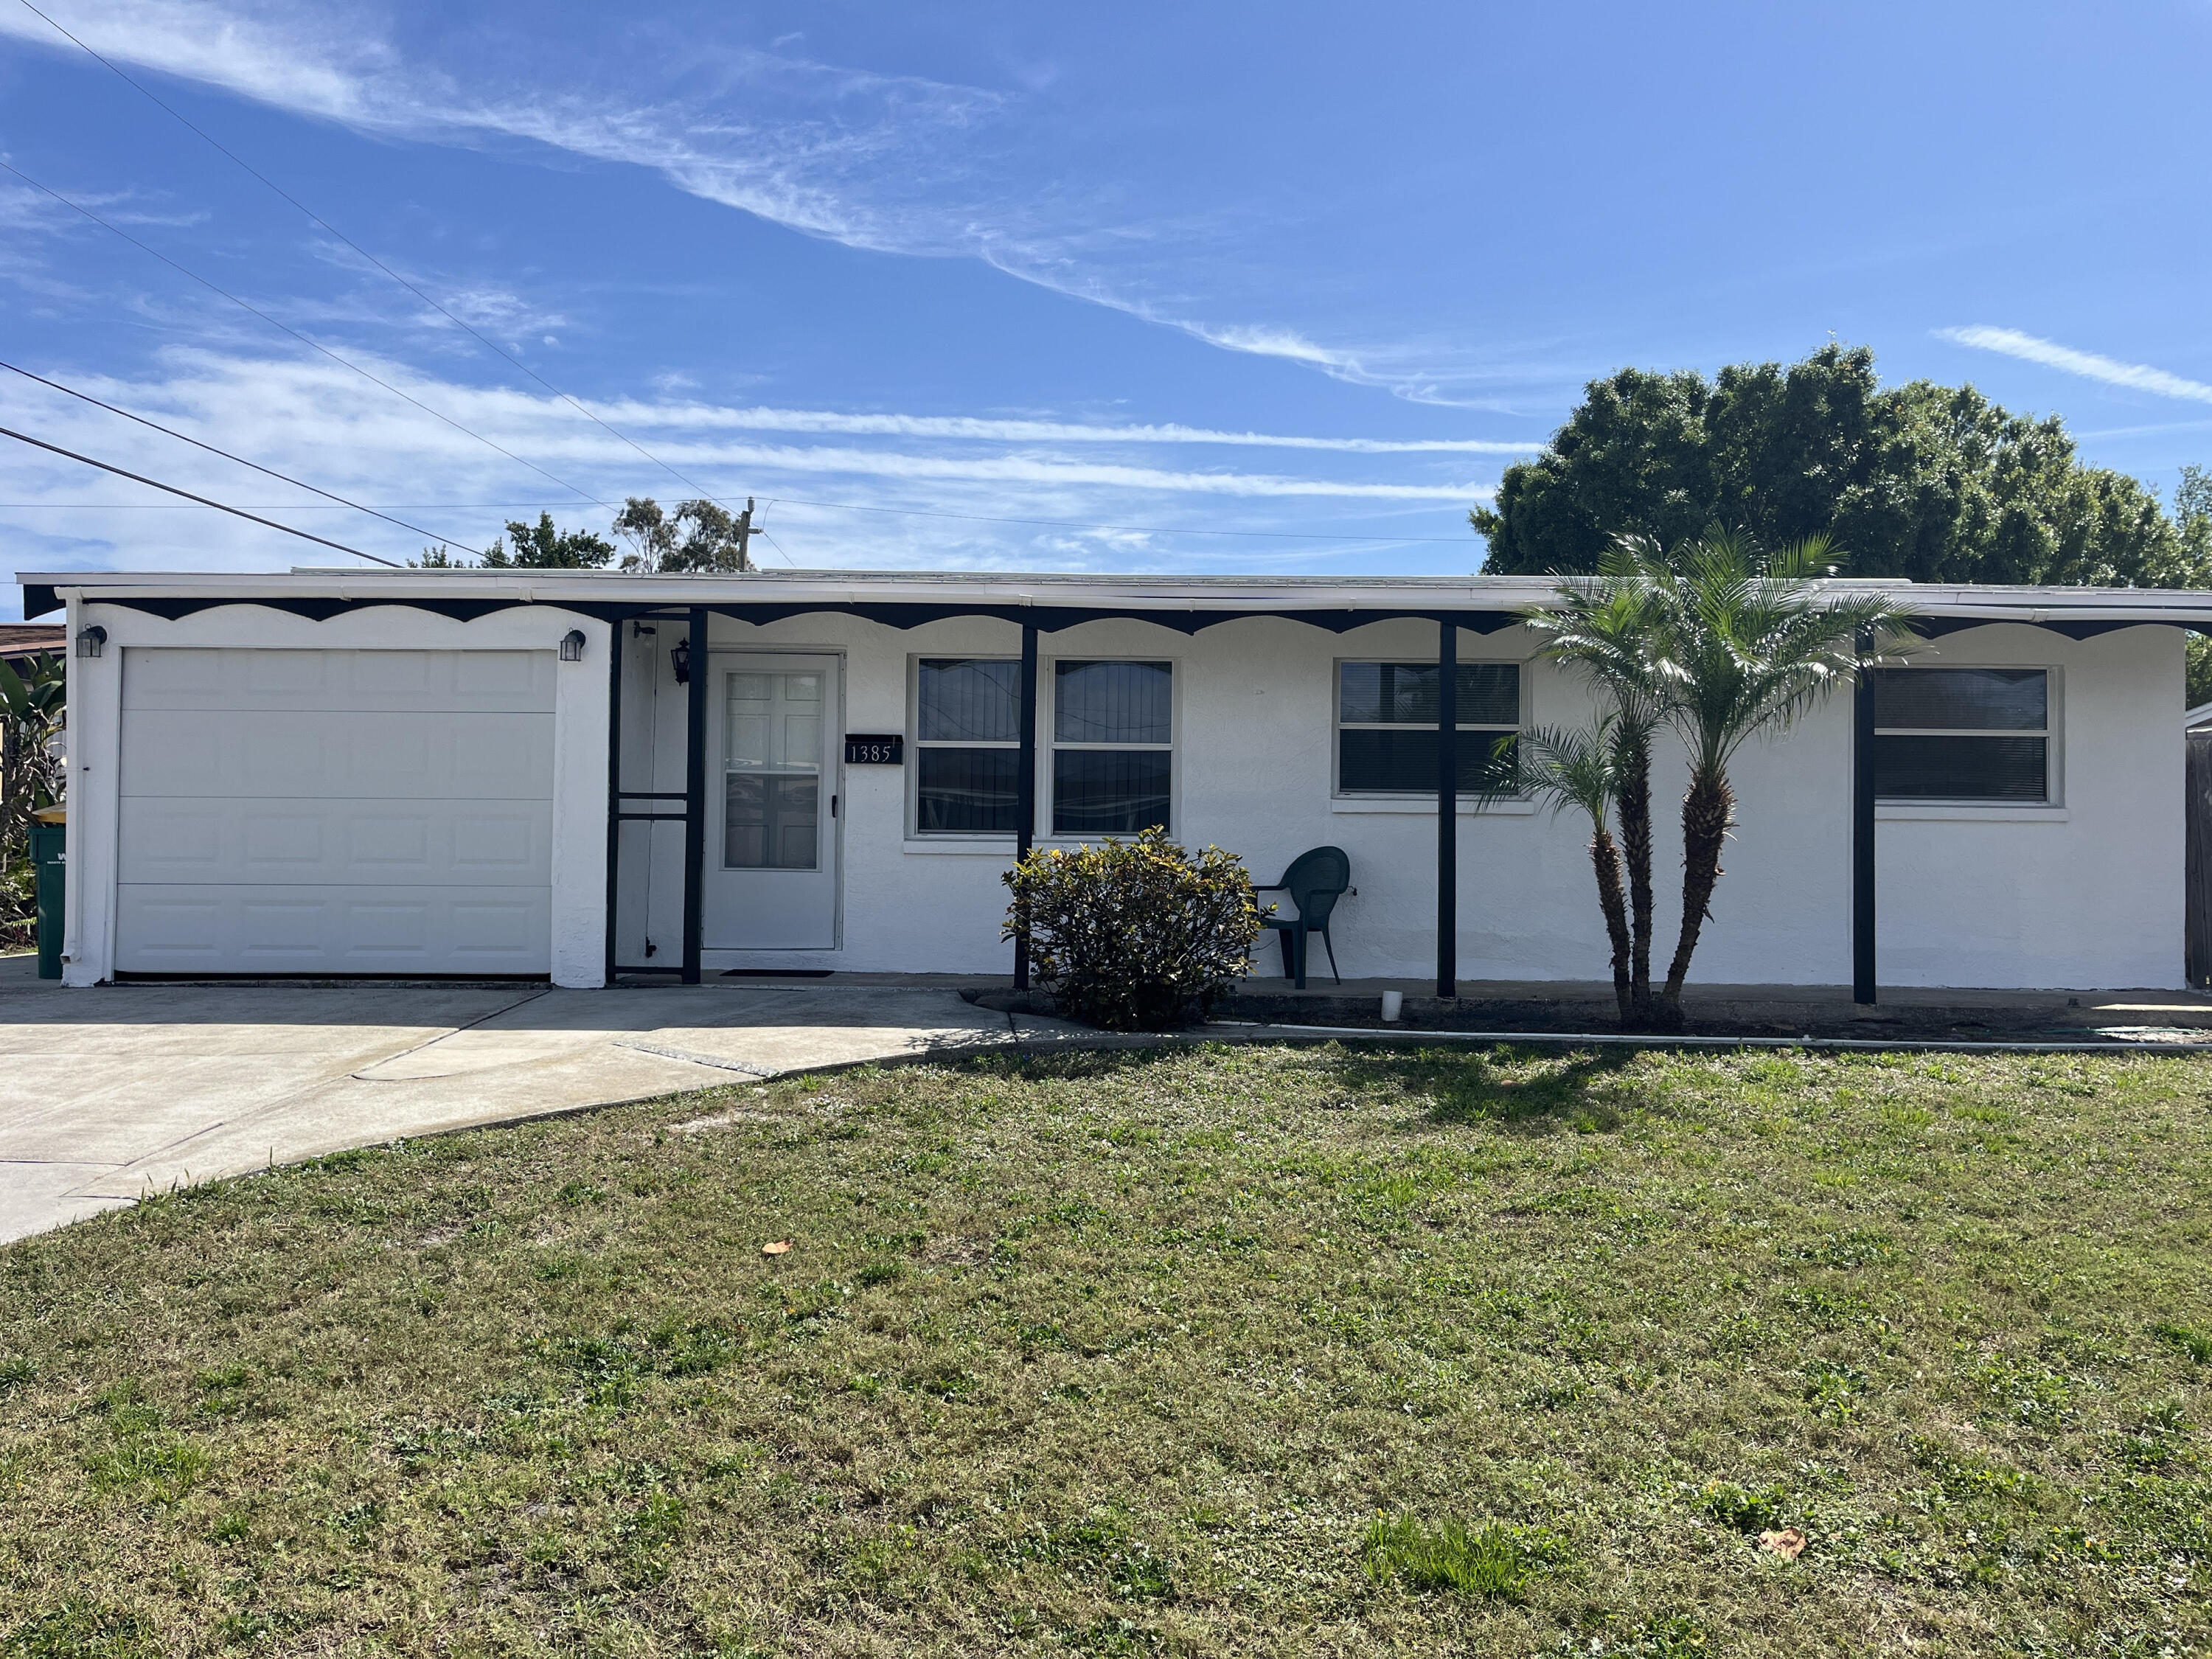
[119,796,553,887]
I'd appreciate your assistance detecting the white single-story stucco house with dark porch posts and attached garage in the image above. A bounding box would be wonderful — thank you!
[20,571,2212,995]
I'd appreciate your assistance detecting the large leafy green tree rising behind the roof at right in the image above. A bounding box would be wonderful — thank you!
[1471,345,2212,586]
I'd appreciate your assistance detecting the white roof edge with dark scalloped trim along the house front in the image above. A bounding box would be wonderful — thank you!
[15,568,2212,635]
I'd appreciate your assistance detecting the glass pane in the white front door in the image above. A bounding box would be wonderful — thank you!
[721,672,823,869]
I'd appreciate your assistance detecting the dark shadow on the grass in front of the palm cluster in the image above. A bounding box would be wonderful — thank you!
[1310,1046,1635,1135]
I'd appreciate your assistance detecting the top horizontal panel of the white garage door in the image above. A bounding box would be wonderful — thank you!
[124,648,553,712]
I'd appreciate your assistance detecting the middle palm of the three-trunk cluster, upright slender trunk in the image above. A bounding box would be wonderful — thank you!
[1522,546,1668,1024]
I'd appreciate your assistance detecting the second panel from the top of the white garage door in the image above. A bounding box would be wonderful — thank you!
[124,708,553,801]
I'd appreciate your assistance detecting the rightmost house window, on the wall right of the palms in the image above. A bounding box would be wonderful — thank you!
[1874,668,2051,803]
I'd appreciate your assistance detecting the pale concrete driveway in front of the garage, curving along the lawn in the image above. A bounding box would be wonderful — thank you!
[0,956,1068,1241]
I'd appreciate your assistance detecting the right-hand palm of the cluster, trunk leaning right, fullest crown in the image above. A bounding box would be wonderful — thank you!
[1630,531,1907,1026]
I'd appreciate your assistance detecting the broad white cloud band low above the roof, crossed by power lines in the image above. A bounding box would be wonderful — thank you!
[0,349,1491,584]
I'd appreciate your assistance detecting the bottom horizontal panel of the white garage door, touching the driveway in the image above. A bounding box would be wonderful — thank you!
[115,883,553,973]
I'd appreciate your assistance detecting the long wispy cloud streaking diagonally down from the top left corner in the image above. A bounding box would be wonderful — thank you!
[0,0,1478,407]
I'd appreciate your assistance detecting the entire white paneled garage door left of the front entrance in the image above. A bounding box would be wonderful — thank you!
[115,648,553,973]
